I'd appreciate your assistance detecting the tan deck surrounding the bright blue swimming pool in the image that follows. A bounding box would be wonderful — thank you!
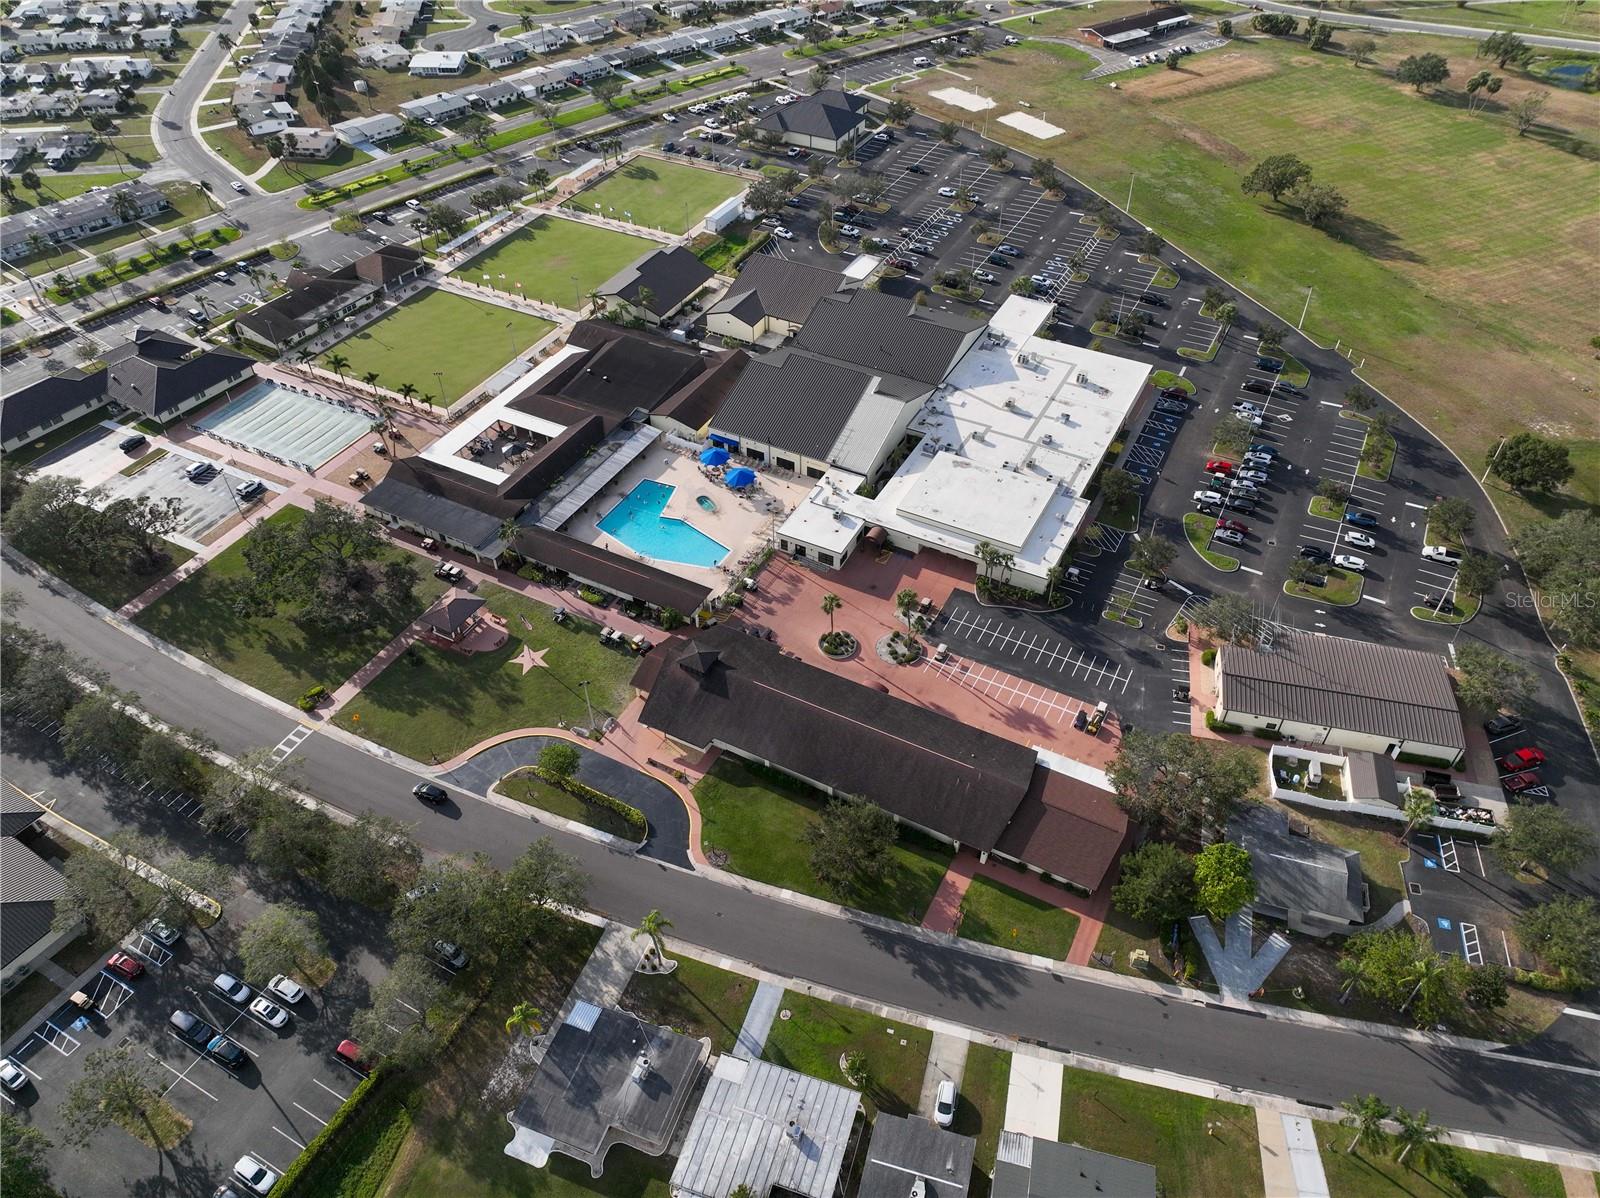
[562,446,811,590]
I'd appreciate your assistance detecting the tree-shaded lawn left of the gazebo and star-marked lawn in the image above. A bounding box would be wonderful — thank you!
[136,507,445,702]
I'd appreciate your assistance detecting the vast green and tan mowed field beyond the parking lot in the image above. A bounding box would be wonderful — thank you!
[896,37,1600,523]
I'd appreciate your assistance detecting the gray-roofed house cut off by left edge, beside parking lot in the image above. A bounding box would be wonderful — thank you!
[0,793,83,993]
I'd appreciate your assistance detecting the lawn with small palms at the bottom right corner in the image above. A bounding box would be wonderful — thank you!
[1317,1123,1566,1198]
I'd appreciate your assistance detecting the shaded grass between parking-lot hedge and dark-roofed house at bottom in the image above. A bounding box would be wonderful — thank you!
[296,921,611,1198]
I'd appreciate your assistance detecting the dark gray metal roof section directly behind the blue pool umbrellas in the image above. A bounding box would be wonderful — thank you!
[712,349,872,461]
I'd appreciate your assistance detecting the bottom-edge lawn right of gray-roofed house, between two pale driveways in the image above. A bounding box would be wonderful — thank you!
[1059,1068,1262,1198]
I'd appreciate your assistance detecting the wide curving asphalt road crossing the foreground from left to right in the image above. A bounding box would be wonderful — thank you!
[0,565,1600,1150]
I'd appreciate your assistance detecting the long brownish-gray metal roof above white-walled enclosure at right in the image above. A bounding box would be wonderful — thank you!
[1218,629,1467,749]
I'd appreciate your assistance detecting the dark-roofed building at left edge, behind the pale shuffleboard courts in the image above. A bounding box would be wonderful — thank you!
[0,328,256,453]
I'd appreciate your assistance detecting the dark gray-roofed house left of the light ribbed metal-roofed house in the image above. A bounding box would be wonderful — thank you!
[505,1004,710,1177]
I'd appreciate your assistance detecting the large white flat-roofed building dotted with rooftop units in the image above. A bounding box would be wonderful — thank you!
[778,296,1150,590]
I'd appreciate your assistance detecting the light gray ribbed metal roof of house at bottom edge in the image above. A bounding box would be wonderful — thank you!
[670,1056,861,1198]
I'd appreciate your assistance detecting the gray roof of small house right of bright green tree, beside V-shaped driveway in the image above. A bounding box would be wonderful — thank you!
[1227,803,1365,923]
